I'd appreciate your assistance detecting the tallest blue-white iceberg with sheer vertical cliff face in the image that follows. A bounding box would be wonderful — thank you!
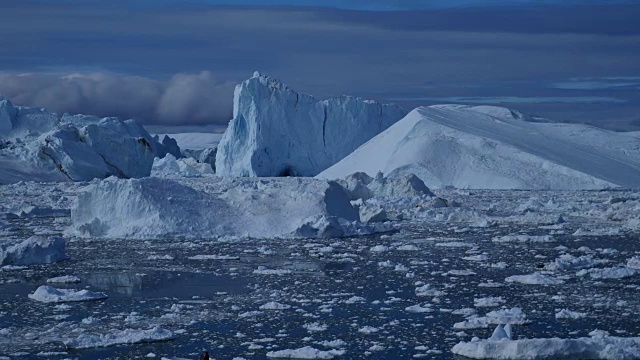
[216,72,406,177]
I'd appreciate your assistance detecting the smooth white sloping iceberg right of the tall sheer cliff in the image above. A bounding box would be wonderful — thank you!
[318,105,640,190]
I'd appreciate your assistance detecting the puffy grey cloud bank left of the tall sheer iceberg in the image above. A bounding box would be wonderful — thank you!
[0,71,234,125]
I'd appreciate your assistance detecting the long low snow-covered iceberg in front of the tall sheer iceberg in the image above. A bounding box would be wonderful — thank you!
[68,177,382,238]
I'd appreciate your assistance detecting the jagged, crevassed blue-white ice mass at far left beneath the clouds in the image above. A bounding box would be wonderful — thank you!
[0,100,179,183]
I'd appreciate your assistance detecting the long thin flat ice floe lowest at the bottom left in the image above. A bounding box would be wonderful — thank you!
[64,327,174,349]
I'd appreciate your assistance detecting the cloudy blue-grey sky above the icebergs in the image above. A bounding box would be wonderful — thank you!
[0,0,640,130]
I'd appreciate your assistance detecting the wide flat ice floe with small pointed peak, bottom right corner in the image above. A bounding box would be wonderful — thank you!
[451,325,640,360]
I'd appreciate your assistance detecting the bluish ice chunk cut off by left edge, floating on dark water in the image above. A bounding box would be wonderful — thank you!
[0,235,67,265]
